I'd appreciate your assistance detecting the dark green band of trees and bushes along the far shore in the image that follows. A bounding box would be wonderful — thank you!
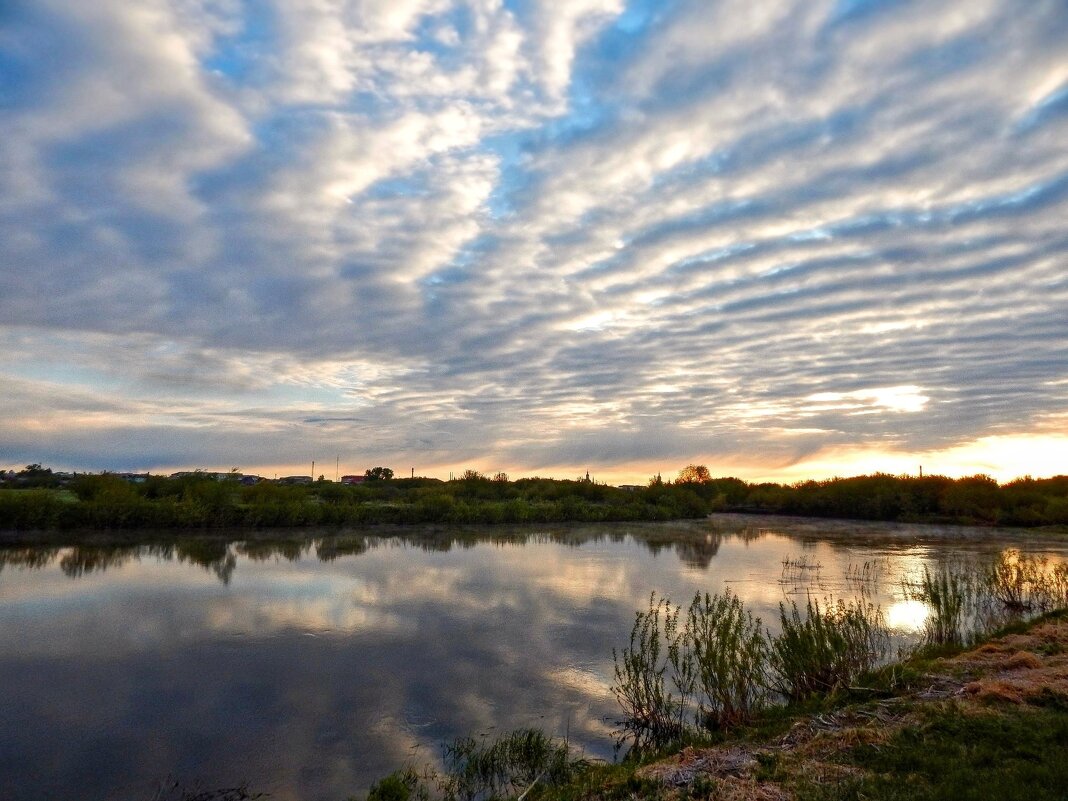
[0,465,1068,530]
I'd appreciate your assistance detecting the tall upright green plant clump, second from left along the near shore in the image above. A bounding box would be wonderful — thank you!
[678,590,768,728]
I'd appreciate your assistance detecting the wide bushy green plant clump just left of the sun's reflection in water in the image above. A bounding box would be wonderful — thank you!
[769,598,890,701]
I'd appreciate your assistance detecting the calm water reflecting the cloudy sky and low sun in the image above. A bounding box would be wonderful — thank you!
[0,516,1068,801]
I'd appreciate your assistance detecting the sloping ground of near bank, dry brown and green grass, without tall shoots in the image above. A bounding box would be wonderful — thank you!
[467,610,1068,801]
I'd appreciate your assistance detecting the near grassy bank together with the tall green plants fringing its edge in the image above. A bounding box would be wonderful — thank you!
[358,551,1068,801]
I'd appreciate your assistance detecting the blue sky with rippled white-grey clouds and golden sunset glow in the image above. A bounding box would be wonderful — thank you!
[0,0,1068,483]
